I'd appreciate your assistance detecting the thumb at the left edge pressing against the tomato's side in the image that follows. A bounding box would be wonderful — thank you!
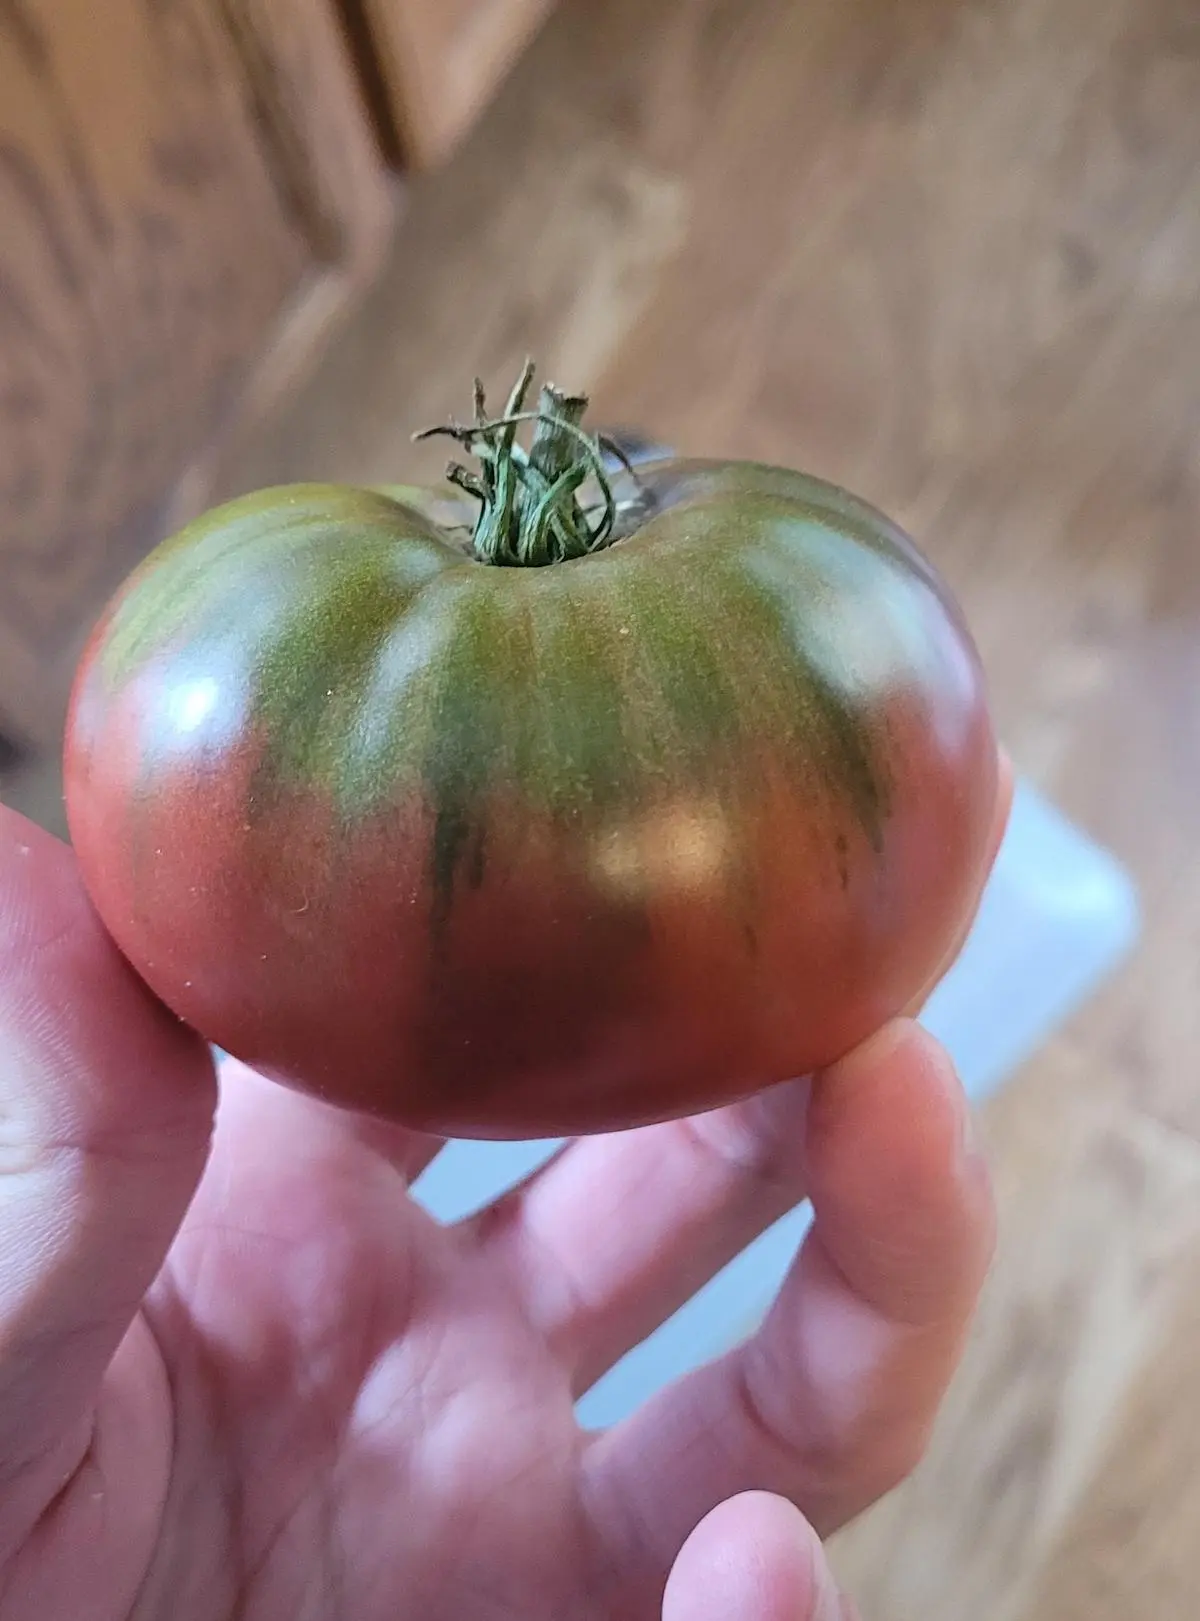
[0,806,216,1535]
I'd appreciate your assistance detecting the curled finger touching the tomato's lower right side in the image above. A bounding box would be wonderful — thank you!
[587,1023,994,1566]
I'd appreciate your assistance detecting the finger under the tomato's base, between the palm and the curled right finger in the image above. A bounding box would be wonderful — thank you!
[469,1083,808,1394]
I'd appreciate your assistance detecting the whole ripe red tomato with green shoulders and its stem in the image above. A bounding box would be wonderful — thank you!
[65,378,997,1138]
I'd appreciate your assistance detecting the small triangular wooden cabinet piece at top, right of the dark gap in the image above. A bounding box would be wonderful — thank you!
[358,0,551,169]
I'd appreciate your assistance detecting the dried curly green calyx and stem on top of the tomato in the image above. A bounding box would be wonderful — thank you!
[415,361,619,567]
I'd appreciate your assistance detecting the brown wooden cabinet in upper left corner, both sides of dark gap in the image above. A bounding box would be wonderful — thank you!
[0,0,546,759]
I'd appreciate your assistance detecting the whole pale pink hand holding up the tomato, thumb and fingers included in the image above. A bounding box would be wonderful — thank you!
[0,768,1007,1621]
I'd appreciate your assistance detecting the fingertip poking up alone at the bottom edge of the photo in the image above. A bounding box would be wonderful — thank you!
[663,1491,855,1621]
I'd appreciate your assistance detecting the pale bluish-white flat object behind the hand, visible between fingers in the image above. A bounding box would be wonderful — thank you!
[415,785,1138,1426]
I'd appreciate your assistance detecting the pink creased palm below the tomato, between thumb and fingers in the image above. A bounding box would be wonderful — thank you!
[131,1076,600,1621]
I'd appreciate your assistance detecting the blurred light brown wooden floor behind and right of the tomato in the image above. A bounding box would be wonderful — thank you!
[16,0,1200,1621]
